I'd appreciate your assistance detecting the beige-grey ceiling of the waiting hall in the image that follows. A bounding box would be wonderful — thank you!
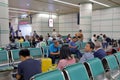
[8,0,120,17]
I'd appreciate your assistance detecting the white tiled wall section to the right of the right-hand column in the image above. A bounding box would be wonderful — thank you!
[92,7,120,39]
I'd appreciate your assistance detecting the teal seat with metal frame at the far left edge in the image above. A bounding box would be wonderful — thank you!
[0,50,13,71]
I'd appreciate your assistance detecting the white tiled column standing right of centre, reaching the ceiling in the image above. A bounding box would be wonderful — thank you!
[79,3,92,41]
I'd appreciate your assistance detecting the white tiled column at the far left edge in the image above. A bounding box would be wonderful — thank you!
[0,0,9,47]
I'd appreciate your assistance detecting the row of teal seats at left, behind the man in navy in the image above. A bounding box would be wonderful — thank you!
[0,46,49,71]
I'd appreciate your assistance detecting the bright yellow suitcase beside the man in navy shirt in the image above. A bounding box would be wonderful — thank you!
[41,58,52,72]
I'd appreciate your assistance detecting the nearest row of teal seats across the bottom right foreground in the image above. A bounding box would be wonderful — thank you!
[31,53,120,80]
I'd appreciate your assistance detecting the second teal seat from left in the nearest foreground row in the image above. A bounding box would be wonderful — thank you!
[64,63,90,80]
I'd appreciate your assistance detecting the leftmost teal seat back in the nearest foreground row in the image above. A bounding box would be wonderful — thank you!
[30,69,65,80]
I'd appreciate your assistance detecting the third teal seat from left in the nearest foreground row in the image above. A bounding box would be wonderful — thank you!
[84,58,108,80]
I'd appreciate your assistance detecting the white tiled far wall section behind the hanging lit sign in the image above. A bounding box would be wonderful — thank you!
[32,13,59,36]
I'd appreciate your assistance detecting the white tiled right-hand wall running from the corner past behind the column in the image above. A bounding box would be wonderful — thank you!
[59,7,120,41]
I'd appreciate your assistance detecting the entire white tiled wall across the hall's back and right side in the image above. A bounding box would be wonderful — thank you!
[10,7,120,41]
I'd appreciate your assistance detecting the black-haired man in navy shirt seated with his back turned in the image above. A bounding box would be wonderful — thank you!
[16,49,41,80]
